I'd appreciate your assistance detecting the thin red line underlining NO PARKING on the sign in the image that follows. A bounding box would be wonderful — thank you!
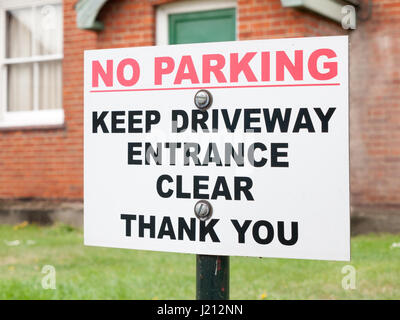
[90,83,340,93]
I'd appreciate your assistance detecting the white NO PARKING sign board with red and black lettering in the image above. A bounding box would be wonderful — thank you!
[84,36,350,260]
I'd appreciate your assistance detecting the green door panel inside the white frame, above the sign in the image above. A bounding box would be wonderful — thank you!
[168,9,236,44]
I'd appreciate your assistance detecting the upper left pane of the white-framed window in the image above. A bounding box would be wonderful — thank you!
[6,8,32,58]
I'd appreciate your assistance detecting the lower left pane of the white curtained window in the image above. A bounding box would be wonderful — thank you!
[7,63,33,111]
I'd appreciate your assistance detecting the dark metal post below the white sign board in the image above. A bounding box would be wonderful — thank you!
[196,255,229,300]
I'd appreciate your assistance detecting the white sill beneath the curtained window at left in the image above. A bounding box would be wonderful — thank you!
[0,109,64,130]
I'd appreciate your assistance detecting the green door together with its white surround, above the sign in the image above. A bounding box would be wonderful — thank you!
[156,0,236,45]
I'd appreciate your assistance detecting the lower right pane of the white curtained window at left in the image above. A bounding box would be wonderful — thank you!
[39,61,62,109]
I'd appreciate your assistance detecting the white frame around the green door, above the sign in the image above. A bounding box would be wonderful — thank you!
[156,0,238,46]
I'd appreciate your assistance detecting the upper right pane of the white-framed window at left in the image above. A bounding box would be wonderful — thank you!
[35,5,63,55]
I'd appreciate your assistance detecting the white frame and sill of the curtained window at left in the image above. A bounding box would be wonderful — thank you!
[0,0,64,130]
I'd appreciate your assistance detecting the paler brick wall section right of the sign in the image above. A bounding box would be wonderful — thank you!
[350,0,400,207]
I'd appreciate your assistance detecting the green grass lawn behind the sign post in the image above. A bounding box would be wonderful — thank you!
[0,225,400,299]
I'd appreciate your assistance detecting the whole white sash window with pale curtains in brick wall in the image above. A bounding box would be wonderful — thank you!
[0,0,64,128]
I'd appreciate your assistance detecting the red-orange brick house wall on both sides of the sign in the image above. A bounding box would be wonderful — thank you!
[0,0,400,215]
